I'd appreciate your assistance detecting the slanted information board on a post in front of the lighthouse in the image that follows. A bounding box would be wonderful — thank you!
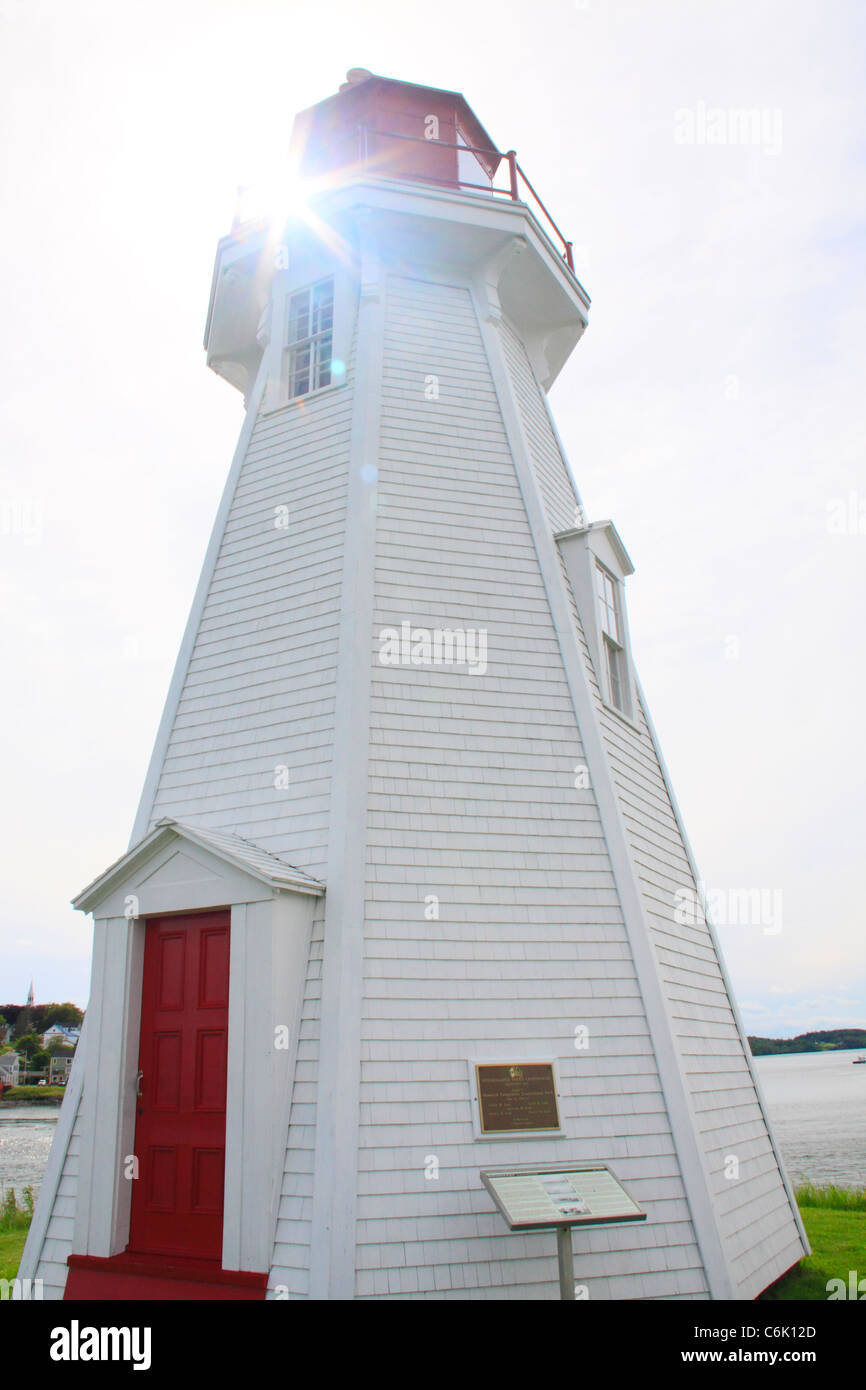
[481,1163,646,1301]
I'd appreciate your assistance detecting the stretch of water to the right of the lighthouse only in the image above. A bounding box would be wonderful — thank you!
[755,1051,866,1187]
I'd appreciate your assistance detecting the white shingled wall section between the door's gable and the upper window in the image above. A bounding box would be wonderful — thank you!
[150,364,352,873]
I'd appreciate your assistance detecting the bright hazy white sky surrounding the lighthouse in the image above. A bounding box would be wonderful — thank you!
[0,0,866,1036]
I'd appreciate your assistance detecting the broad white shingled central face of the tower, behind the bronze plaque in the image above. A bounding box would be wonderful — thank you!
[356,278,706,1298]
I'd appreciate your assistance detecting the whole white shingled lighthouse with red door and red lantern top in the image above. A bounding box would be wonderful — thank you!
[21,70,808,1300]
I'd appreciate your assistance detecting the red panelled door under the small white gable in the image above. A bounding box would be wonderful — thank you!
[126,910,231,1265]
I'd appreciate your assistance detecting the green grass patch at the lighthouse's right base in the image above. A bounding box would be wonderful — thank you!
[760,1183,866,1302]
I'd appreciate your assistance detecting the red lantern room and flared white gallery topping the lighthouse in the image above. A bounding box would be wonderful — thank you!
[204,68,589,397]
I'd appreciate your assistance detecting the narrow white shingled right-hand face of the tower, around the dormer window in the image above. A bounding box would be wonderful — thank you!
[503,324,802,1298]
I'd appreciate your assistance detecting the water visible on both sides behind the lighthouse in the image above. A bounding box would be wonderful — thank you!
[0,1051,866,1193]
